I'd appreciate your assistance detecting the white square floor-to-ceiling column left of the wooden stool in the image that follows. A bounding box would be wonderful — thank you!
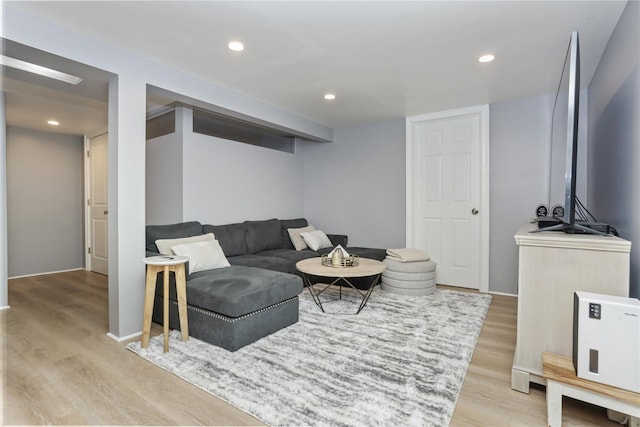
[108,74,146,340]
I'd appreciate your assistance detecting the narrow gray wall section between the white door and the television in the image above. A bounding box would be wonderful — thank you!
[489,97,553,294]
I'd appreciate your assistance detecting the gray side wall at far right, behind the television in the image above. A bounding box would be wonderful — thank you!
[589,1,640,298]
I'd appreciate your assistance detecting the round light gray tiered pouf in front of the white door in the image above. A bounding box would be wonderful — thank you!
[380,257,437,295]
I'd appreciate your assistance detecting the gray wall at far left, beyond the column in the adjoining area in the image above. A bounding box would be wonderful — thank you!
[7,127,84,277]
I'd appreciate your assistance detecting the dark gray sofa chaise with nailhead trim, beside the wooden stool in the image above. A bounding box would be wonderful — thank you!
[153,265,303,351]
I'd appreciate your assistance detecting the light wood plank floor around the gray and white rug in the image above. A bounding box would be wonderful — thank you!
[0,271,618,426]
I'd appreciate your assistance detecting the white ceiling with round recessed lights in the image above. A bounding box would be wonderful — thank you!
[3,0,626,133]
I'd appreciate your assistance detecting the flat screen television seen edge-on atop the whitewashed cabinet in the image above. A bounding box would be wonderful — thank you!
[537,31,607,234]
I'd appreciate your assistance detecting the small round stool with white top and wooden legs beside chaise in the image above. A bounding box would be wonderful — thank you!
[142,255,189,353]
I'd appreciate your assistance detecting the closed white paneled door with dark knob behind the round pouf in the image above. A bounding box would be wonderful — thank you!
[407,111,488,292]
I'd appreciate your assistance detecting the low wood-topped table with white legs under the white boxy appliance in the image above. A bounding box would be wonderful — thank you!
[542,353,640,427]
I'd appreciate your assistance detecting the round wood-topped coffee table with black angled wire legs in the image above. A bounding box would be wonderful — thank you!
[296,258,387,314]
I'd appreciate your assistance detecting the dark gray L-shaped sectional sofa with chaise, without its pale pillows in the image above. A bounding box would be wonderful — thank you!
[146,218,386,351]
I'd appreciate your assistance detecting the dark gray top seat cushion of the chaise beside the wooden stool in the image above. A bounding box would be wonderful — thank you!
[156,265,303,317]
